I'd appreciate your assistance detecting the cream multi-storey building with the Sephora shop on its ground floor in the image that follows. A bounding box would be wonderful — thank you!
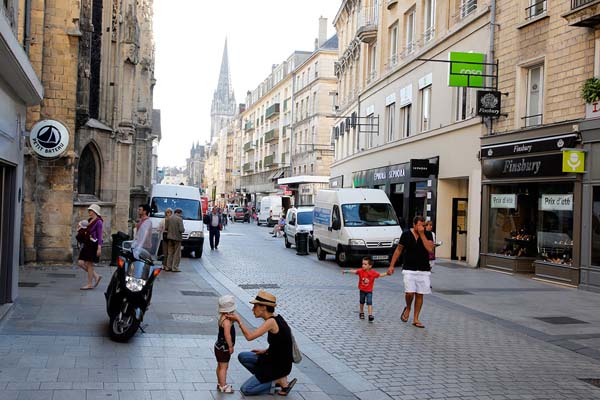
[330,0,490,265]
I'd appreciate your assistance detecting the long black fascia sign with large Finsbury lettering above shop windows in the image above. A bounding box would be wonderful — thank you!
[482,154,563,178]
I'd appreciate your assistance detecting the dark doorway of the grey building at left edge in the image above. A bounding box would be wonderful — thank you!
[0,163,15,304]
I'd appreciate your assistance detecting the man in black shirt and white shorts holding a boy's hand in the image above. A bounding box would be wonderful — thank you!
[387,216,435,328]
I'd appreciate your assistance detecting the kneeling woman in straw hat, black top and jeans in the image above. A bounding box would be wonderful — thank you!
[227,290,296,396]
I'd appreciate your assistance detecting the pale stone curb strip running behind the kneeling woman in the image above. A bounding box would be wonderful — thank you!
[194,258,391,400]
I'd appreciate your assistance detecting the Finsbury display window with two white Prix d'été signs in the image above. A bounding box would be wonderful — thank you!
[488,183,573,265]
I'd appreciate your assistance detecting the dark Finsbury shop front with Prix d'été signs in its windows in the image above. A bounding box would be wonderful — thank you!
[481,127,582,285]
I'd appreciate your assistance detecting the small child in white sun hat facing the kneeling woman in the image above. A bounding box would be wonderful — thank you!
[215,295,235,393]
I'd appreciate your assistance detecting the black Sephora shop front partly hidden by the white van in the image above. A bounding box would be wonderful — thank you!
[352,157,439,229]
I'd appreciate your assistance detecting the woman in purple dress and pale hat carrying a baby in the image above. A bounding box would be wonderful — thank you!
[78,204,103,290]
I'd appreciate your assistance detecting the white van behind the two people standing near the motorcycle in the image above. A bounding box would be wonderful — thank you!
[150,184,204,258]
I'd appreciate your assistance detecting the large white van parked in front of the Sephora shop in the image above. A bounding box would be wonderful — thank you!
[313,189,402,268]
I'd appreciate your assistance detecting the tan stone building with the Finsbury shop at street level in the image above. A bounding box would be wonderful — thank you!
[481,0,600,290]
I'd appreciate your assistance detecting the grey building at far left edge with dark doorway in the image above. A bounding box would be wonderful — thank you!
[0,0,44,304]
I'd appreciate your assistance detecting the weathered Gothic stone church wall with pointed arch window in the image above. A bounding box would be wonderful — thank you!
[23,0,159,263]
